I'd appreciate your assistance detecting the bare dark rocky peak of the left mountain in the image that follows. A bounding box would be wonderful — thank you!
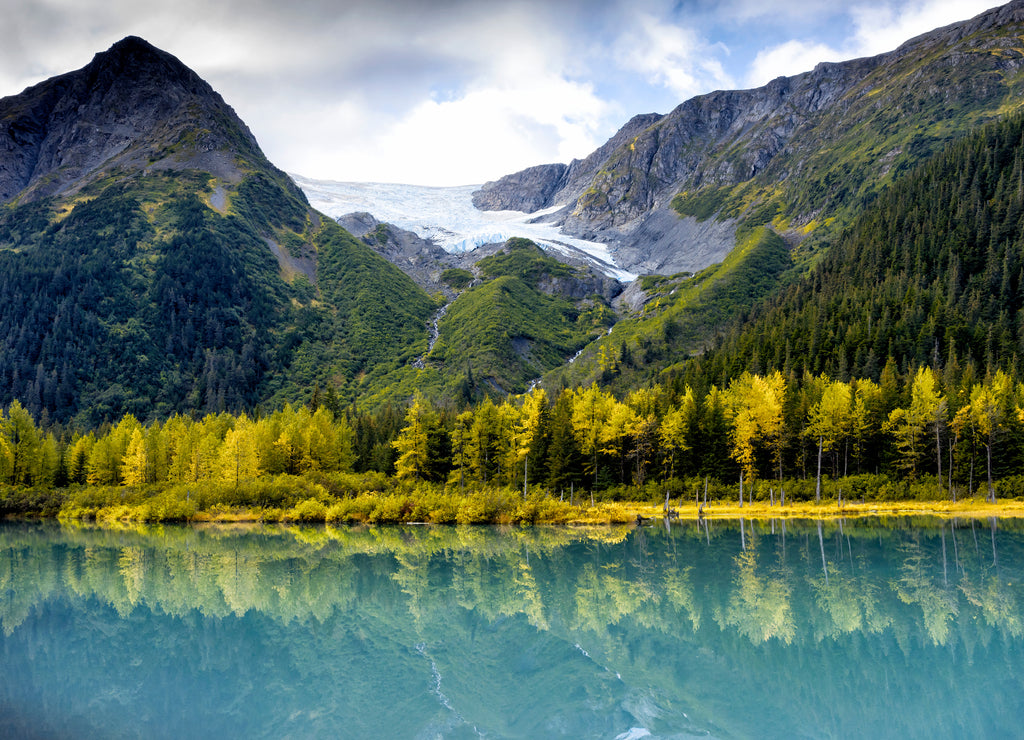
[0,37,268,203]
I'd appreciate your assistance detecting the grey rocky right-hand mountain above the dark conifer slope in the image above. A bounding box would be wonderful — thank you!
[474,0,1024,274]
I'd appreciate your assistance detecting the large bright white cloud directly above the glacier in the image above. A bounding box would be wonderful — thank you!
[266,7,622,185]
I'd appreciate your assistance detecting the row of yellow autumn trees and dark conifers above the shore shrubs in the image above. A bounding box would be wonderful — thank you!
[0,360,1024,500]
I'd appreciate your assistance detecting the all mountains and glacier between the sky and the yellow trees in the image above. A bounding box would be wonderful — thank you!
[6,0,1024,428]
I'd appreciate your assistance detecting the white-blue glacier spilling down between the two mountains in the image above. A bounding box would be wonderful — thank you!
[292,174,636,282]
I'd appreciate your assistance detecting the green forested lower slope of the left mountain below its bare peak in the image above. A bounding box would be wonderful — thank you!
[0,170,433,424]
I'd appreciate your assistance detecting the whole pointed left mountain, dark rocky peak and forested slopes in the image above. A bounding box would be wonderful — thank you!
[0,38,436,425]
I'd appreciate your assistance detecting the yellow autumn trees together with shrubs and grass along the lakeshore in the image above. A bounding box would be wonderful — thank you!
[6,354,1024,524]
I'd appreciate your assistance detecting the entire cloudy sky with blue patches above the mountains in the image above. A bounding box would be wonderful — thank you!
[0,0,1000,185]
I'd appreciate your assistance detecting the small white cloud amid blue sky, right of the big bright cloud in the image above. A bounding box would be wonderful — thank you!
[615,14,733,99]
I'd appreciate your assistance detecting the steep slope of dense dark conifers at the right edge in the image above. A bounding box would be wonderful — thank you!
[691,110,1024,380]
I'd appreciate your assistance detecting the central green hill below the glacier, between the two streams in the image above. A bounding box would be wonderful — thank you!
[342,237,622,407]
